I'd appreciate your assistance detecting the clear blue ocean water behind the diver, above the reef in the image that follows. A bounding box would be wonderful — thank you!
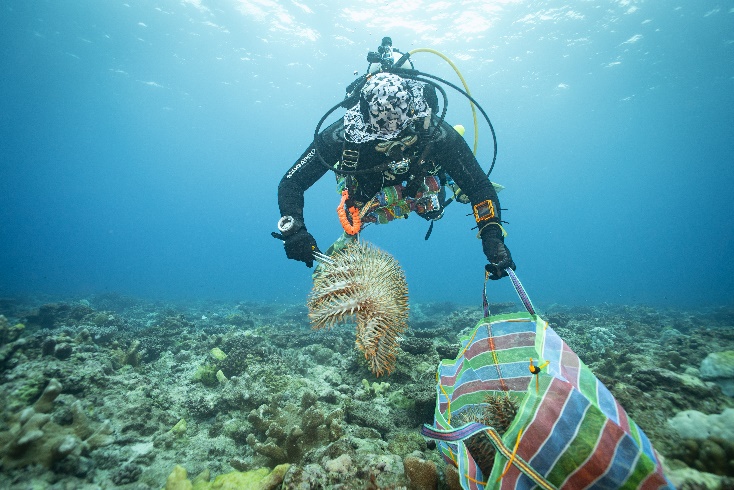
[0,0,734,305]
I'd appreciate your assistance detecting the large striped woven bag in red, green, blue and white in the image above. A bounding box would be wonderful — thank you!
[422,269,674,490]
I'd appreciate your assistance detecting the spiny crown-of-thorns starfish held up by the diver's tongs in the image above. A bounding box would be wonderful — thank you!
[308,242,408,376]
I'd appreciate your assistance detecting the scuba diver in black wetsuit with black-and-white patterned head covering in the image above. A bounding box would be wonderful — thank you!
[272,37,515,279]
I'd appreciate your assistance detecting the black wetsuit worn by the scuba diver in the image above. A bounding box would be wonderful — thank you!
[278,117,500,228]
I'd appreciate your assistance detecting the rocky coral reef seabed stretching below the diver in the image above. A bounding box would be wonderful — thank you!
[0,295,734,490]
